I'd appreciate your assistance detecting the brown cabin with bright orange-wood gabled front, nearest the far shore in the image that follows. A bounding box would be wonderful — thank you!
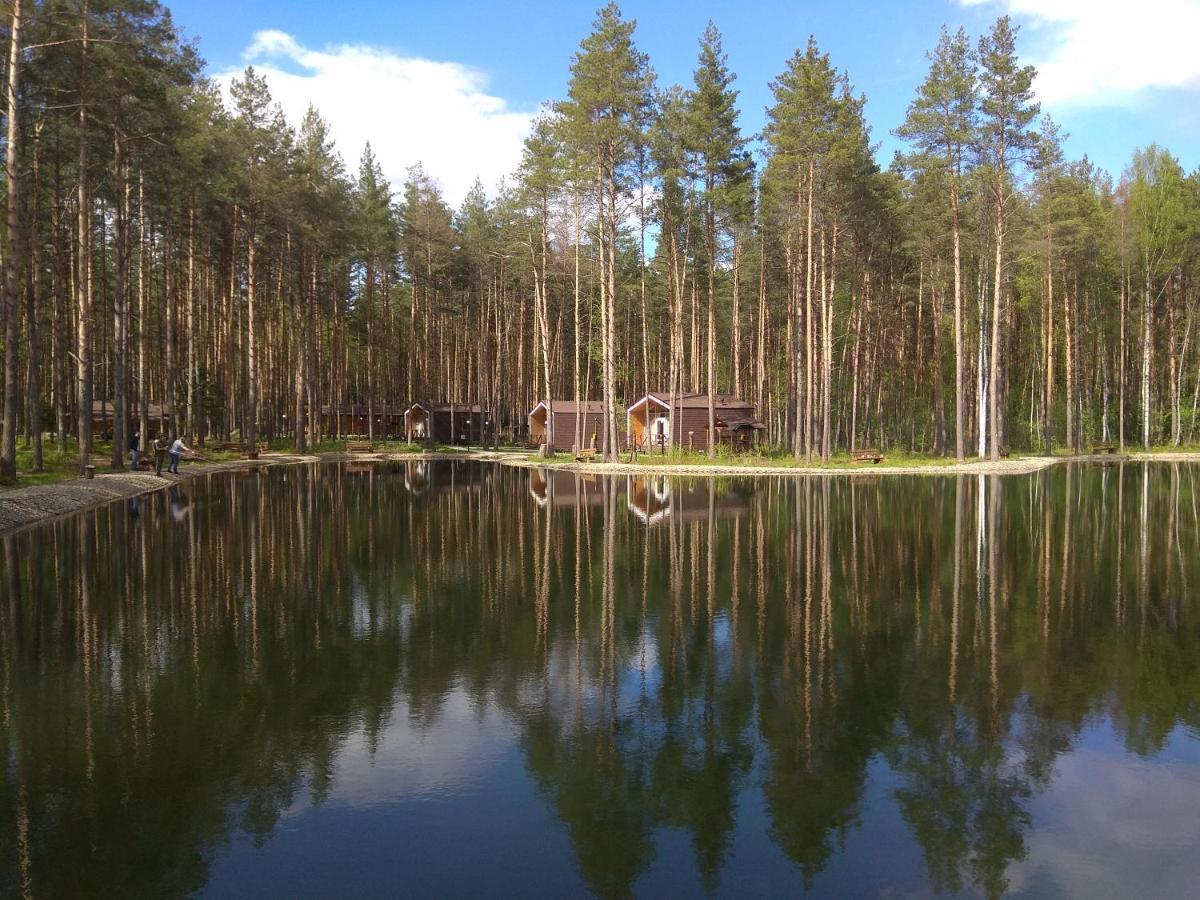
[629,391,767,450]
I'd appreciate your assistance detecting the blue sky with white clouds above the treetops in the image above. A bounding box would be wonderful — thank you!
[169,0,1200,202]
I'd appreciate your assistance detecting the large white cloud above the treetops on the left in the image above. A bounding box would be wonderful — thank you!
[217,30,534,206]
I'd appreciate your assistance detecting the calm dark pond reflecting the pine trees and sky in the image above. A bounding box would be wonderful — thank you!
[0,462,1200,898]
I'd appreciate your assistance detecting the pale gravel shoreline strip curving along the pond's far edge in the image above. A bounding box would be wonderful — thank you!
[0,450,1200,536]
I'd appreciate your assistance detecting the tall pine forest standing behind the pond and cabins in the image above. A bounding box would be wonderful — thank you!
[0,0,1200,482]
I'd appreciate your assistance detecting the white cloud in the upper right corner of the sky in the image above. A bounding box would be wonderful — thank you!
[959,0,1200,106]
